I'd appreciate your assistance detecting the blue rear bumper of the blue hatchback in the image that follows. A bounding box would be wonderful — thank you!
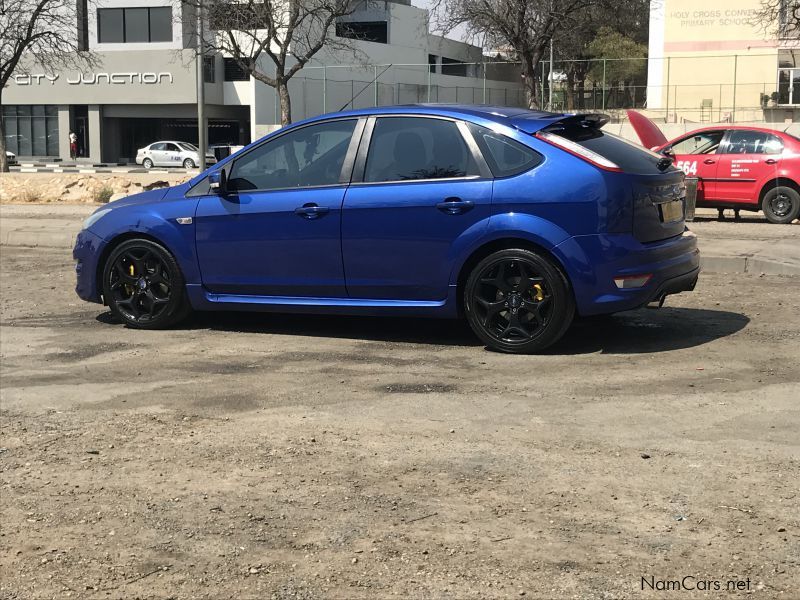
[557,230,700,315]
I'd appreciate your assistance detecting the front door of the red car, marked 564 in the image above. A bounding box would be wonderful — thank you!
[669,129,725,202]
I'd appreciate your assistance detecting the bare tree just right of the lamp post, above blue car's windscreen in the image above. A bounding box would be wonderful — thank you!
[194,0,355,125]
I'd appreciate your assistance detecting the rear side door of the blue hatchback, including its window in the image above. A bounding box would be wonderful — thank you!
[342,116,492,300]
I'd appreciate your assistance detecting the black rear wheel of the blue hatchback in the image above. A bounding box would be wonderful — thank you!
[464,248,575,354]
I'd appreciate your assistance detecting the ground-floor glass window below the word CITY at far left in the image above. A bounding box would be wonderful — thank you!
[3,104,58,156]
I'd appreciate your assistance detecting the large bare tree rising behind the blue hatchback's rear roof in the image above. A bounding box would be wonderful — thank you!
[433,0,598,108]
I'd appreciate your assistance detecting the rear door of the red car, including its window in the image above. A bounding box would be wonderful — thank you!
[716,129,783,204]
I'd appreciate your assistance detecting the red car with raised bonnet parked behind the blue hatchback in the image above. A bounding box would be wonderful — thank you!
[628,110,800,223]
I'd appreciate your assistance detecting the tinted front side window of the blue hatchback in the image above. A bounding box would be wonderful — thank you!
[229,120,356,190]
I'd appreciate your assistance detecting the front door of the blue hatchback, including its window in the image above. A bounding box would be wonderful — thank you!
[196,119,357,298]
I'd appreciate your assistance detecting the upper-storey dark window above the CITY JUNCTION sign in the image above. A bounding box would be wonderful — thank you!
[97,6,172,44]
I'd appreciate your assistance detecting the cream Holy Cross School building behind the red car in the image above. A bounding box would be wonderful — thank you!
[647,0,800,122]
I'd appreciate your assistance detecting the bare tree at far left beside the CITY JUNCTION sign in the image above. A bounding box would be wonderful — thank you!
[0,0,93,173]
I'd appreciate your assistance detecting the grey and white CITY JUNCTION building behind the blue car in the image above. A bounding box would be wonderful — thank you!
[2,0,524,163]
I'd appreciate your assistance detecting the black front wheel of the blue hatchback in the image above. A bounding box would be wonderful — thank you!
[102,239,191,329]
